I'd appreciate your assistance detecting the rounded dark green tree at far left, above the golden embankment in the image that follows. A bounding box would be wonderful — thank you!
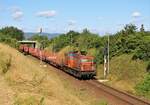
[0,26,24,40]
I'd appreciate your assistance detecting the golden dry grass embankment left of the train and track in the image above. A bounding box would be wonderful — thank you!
[0,44,105,105]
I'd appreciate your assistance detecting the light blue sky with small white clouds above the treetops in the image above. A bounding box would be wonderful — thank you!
[0,0,150,34]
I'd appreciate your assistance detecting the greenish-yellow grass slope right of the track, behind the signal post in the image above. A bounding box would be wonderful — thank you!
[98,55,146,93]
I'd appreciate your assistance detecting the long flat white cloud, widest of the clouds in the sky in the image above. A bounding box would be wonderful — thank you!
[36,10,56,18]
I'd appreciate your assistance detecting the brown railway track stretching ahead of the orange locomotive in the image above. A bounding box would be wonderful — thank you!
[86,80,150,105]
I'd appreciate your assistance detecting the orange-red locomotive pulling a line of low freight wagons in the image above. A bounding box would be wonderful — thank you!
[19,44,96,79]
